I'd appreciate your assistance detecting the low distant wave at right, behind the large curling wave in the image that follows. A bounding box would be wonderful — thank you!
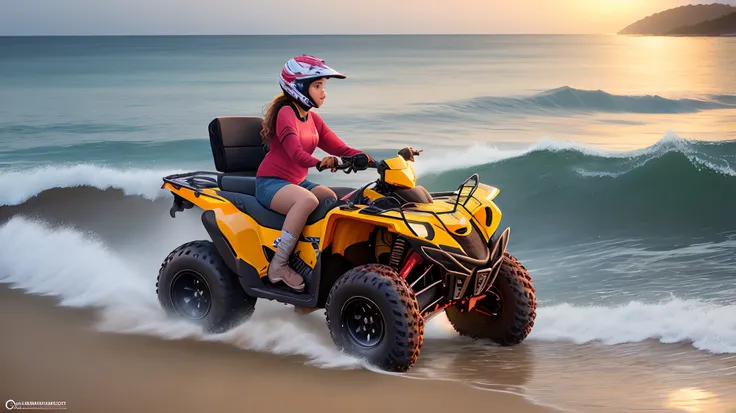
[434,86,736,115]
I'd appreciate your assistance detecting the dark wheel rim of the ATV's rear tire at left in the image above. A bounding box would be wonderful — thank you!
[171,270,211,320]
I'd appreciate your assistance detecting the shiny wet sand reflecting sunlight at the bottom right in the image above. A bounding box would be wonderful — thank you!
[410,333,736,413]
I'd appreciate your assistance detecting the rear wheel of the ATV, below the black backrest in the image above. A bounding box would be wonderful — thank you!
[156,241,256,333]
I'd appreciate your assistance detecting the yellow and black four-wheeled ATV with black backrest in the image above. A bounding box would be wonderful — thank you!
[156,117,536,371]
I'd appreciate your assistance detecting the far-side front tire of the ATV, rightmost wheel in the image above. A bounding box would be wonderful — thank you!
[445,253,537,346]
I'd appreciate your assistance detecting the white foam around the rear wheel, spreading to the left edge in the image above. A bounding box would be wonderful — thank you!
[0,217,362,368]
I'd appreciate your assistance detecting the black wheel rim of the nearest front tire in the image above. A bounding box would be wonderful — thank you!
[340,297,386,347]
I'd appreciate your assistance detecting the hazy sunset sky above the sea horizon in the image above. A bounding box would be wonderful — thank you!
[0,0,736,35]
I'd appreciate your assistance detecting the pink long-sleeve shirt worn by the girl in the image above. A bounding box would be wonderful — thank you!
[256,105,361,185]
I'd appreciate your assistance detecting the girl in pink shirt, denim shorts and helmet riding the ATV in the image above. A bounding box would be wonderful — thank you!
[256,55,362,291]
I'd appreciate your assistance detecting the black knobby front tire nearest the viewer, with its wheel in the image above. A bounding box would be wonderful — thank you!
[325,264,424,372]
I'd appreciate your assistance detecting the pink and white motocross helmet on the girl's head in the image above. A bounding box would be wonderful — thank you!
[279,55,346,110]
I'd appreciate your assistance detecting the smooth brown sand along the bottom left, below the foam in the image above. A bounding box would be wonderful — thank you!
[0,285,555,413]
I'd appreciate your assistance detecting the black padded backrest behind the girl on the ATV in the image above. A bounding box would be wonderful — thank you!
[208,116,268,174]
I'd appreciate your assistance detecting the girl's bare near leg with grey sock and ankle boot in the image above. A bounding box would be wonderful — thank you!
[268,184,319,291]
